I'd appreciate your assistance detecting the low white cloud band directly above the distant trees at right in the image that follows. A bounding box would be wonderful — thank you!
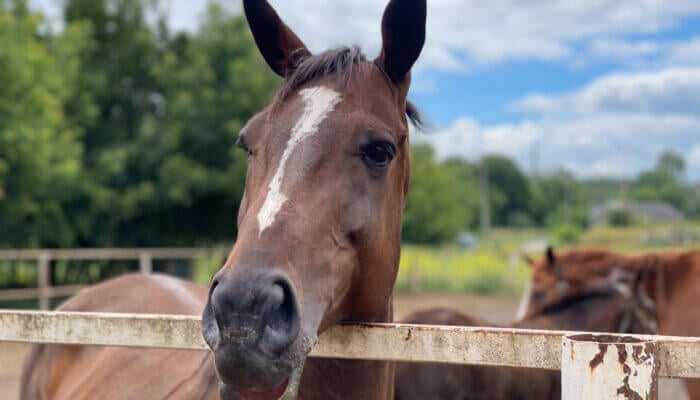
[413,114,700,179]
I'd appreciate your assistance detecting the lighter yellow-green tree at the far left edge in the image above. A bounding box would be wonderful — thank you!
[0,0,89,247]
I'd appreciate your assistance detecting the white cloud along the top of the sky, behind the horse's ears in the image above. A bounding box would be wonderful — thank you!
[31,0,700,70]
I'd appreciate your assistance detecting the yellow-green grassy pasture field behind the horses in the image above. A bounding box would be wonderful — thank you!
[0,222,700,308]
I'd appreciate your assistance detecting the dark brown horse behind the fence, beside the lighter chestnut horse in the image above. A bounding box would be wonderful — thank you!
[395,272,653,400]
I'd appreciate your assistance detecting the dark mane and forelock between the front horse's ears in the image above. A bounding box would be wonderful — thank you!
[278,46,423,128]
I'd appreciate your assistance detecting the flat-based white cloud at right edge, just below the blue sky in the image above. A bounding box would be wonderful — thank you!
[513,67,700,115]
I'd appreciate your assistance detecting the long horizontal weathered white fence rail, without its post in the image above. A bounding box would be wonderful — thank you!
[0,311,700,378]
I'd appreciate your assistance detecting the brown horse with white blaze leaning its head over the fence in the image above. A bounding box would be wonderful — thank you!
[24,0,426,400]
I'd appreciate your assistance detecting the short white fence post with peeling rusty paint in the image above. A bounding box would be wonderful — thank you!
[561,334,660,400]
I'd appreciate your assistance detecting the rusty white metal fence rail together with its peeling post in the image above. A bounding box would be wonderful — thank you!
[0,311,700,400]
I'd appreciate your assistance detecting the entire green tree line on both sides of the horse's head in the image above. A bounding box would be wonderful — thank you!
[0,0,700,247]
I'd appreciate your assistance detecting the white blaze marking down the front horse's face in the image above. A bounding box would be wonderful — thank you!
[258,86,340,234]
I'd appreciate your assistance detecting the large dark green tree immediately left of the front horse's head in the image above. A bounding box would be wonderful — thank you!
[58,0,279,246]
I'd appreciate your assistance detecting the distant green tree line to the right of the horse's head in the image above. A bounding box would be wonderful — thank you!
[403,145,700,243]
